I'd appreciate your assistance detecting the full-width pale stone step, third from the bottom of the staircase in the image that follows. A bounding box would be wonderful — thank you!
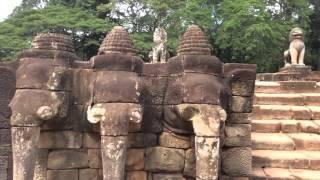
[251,133,320,151]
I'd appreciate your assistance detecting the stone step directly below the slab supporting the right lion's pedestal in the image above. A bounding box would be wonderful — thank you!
[255,81,320,94]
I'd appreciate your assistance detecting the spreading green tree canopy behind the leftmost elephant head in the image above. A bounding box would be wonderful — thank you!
[0,5,112,60]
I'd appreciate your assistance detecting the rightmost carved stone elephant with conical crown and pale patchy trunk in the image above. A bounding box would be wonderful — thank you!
[164,26,229,180]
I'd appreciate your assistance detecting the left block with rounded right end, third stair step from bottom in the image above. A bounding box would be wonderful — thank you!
[251,133,295,150]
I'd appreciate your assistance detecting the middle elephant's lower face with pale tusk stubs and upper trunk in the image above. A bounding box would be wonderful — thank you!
[88,103,142,136]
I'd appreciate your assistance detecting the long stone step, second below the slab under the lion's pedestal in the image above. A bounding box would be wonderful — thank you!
[254,93,320,106]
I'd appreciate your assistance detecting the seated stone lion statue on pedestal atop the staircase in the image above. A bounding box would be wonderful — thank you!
[284,27,305,67]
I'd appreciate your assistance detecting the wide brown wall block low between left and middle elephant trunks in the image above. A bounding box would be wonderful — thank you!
[48,150,89,169]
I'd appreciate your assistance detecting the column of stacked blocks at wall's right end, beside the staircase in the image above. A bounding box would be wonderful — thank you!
[221,64,256,179]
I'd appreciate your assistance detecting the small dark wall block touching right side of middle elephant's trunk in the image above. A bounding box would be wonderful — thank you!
[128,133,157,148]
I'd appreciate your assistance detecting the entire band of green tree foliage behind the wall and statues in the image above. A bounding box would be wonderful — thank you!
[0,0,320,72]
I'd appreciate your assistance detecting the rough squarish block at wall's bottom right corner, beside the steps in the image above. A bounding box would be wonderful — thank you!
[222,147,252,176]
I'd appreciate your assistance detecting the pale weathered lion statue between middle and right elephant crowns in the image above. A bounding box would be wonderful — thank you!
[149,27,167,63]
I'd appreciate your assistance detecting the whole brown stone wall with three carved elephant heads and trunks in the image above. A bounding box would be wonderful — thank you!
[0,26,256,180]
